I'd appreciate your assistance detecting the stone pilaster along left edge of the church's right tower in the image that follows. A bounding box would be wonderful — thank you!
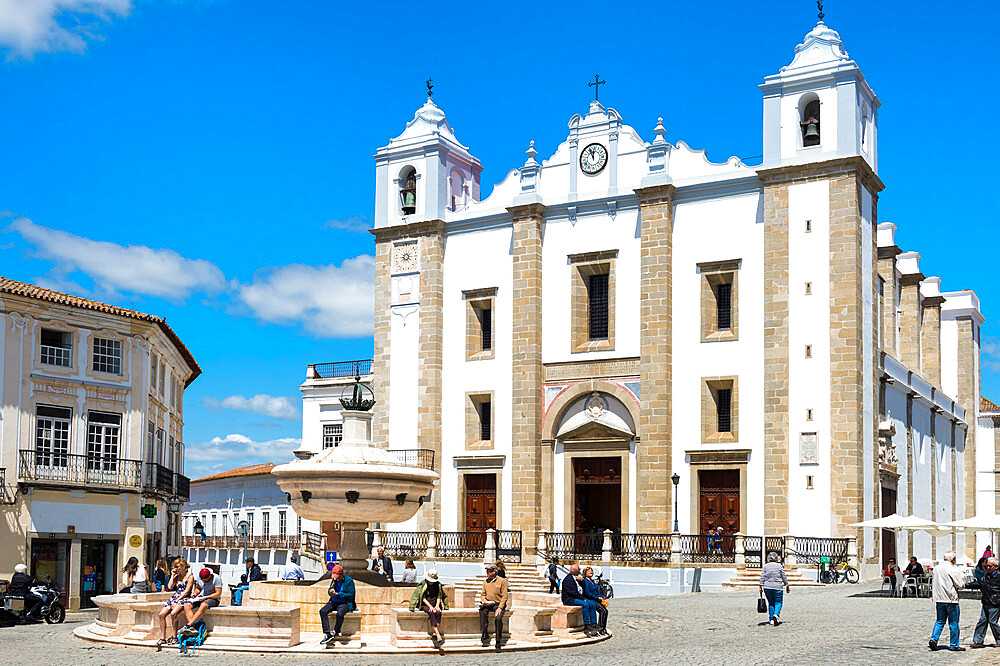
[761,180,792,536]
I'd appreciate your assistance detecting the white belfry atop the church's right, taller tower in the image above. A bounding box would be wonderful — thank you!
[760,18,881,174]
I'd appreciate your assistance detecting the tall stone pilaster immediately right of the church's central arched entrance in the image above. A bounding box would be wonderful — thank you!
[635,185,679,528]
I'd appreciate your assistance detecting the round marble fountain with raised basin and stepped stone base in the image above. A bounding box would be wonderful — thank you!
[74,380,606,654]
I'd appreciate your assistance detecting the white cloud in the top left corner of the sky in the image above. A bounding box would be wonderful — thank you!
[0,0,132,57]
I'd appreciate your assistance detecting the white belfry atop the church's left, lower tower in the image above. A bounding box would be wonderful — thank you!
[375,89,483,229]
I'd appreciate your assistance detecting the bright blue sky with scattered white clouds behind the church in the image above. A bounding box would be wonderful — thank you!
[0,0,1000,476]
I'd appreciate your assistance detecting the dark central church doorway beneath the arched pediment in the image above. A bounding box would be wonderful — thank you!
[573,457,622,534]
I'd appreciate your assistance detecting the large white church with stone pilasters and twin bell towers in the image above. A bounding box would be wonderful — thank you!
[372,22,994,563]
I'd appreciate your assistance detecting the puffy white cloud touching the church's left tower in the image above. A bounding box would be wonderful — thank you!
[239,254,375,338]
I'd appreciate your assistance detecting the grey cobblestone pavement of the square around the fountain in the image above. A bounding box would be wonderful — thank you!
[0,584,1000,666]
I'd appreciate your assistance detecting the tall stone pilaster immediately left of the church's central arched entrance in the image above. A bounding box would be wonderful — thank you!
[507,203,545,544]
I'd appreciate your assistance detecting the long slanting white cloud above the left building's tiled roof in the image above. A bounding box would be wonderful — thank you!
[7,217,226,300]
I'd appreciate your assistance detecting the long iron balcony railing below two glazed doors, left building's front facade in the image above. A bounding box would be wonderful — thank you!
[18,450,142,488]
